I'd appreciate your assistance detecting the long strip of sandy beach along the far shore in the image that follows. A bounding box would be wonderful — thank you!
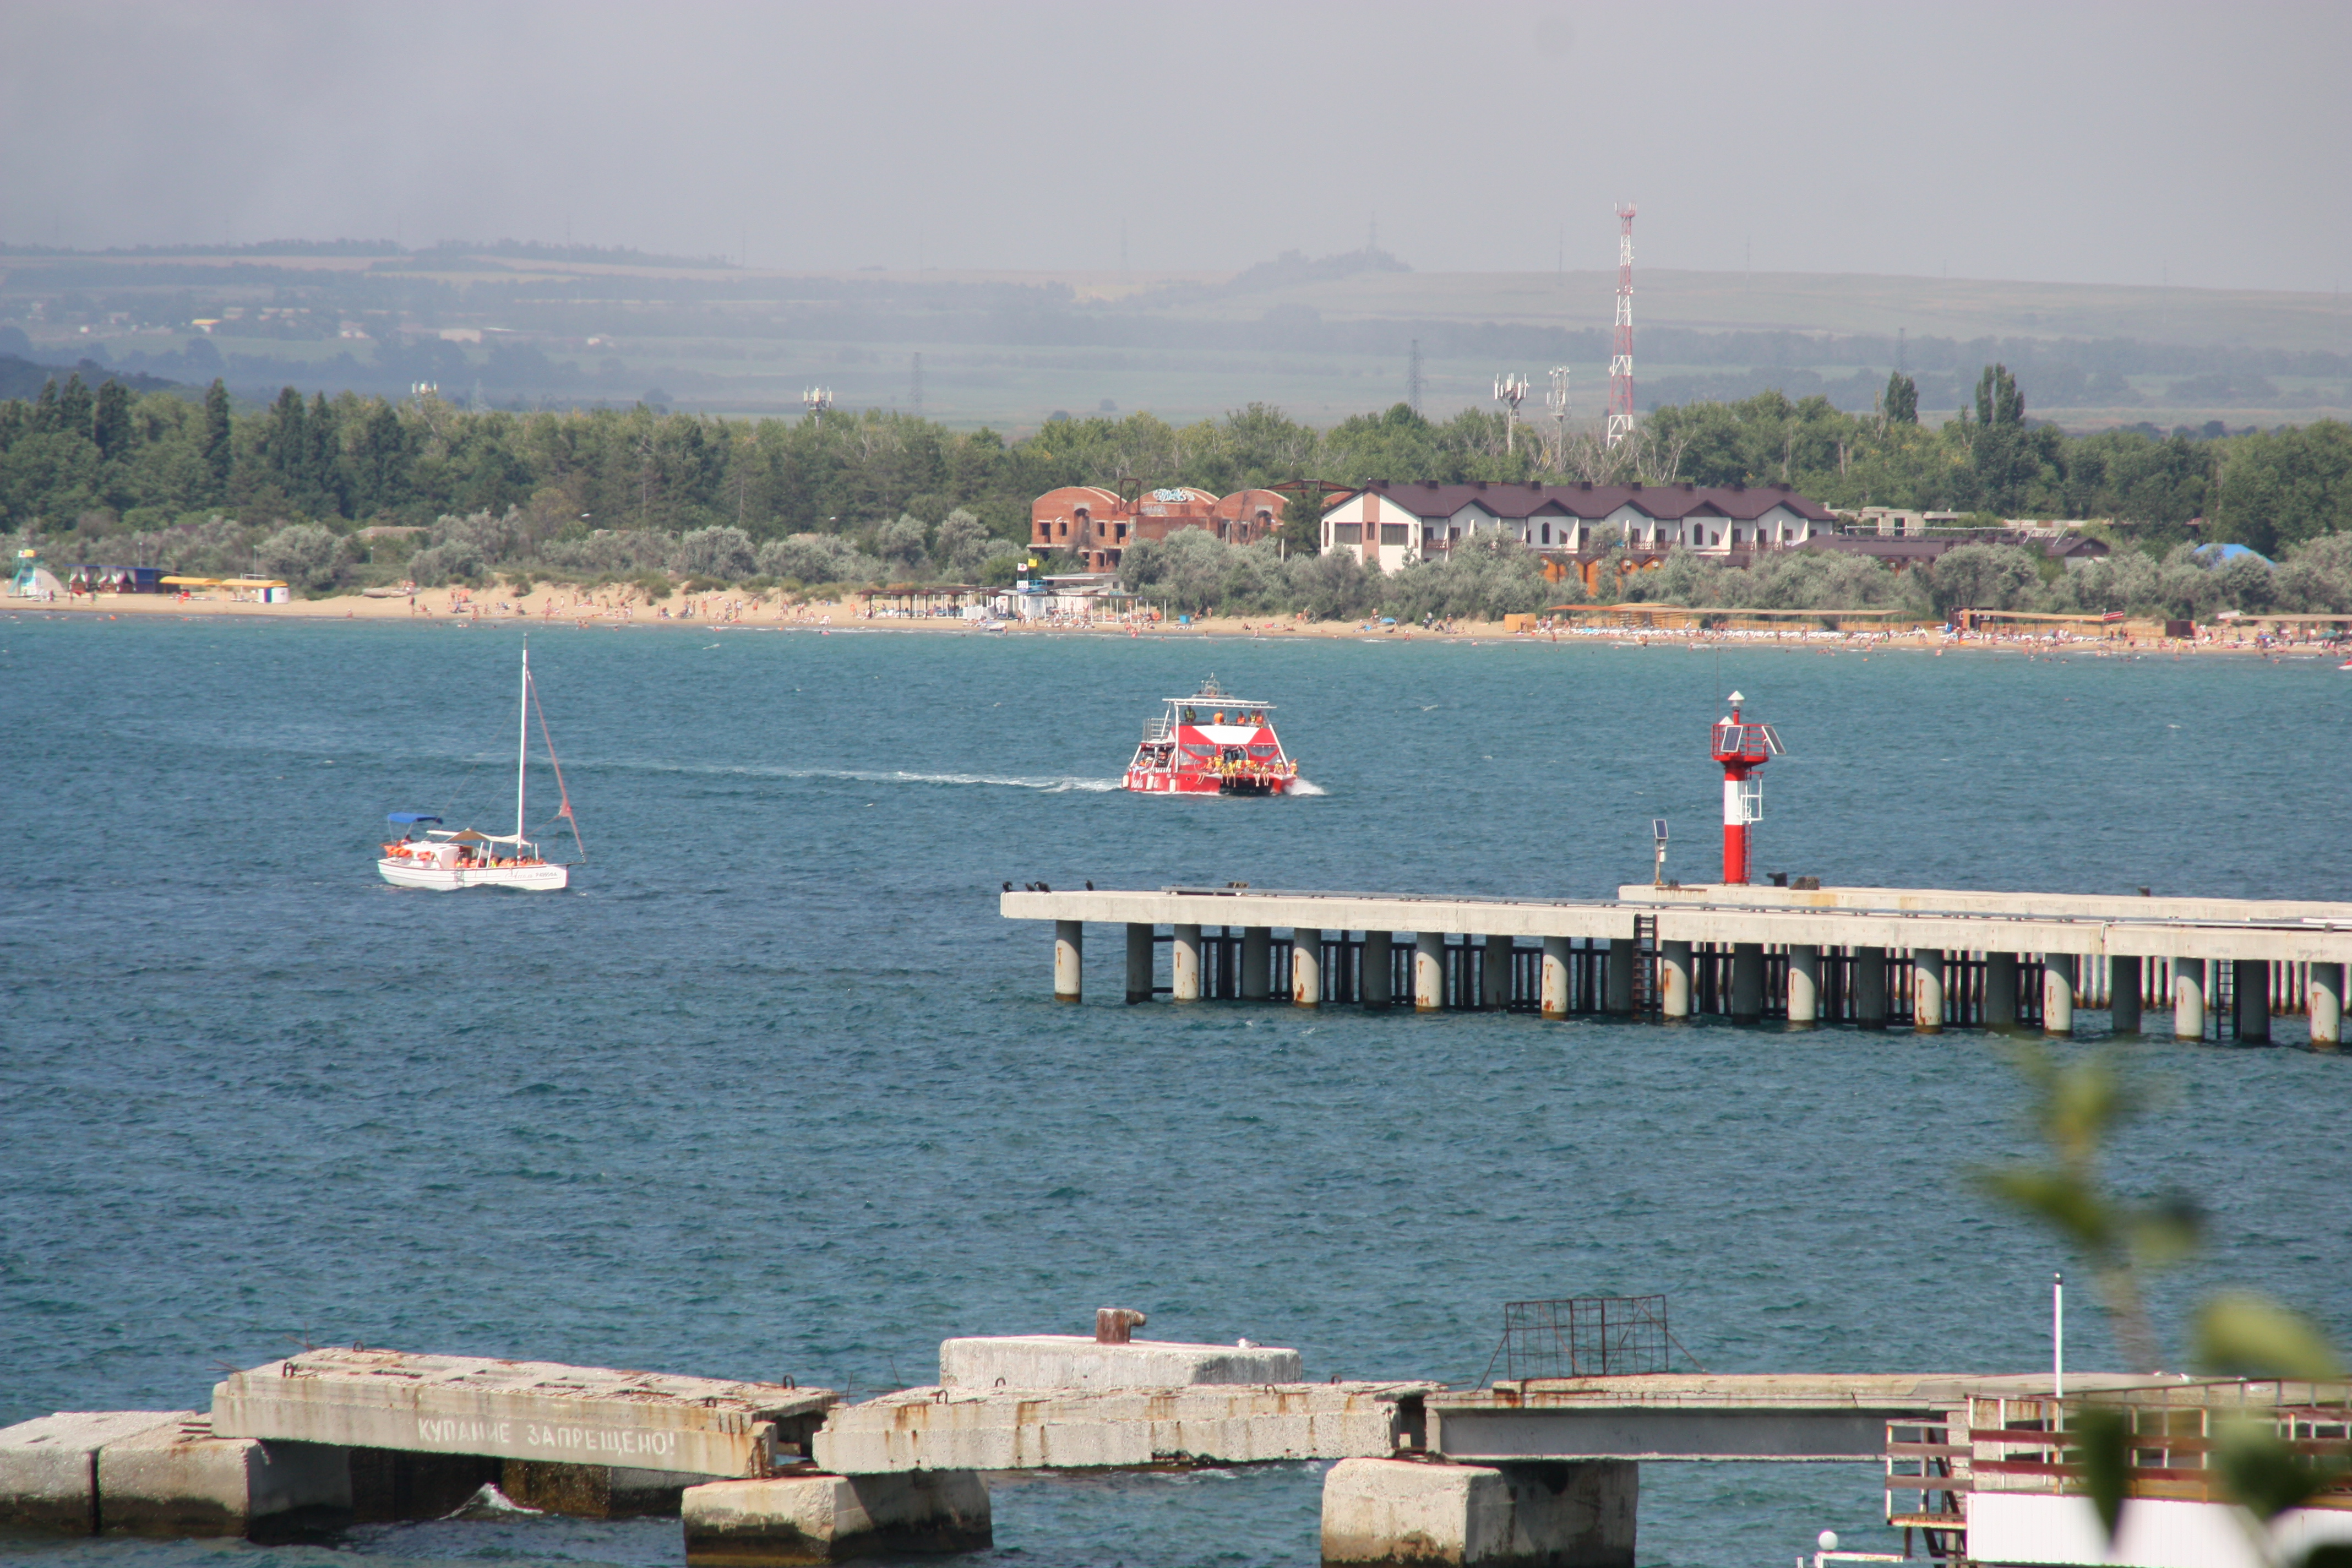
[5,587,2328,656]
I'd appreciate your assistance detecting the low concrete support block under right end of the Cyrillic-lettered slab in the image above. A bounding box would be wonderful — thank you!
[680,1469,995,1568]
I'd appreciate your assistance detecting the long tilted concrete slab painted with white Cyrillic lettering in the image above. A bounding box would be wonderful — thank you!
[211,1349,835,1479]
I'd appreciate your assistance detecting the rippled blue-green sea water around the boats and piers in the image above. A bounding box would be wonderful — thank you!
[0,613,2352,1568]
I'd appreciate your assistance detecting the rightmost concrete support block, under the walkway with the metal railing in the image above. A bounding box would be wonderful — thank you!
[1322,1460,1640,1568]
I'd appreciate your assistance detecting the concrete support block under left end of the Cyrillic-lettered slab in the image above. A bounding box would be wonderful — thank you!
[99,1411,351,1535]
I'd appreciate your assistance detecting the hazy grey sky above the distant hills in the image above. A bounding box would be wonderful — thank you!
[0,0,2352,289]
